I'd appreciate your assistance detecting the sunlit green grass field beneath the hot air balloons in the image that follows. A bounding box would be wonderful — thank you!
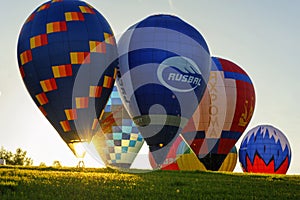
[0,166,300,200]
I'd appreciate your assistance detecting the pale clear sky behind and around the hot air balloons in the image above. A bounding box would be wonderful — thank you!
[0,0,300,174]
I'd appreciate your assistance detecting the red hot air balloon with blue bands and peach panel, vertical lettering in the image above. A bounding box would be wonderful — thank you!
[182,57,255,171]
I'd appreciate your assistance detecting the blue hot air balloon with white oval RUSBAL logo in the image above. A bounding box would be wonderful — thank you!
[117,14,211,164]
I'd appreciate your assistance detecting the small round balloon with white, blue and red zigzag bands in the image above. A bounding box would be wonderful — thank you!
[239,125,292,174]
